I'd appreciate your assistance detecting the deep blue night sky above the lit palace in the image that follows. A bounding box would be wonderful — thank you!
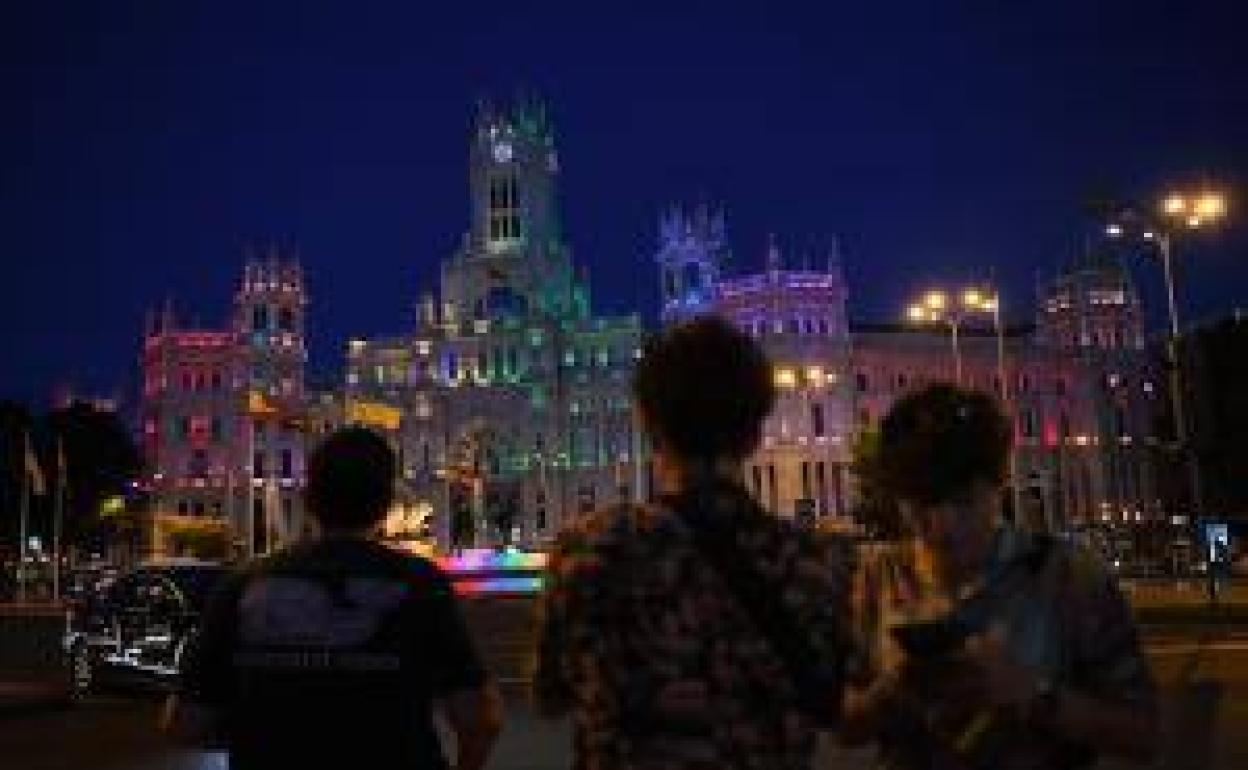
[0,0,1248,401]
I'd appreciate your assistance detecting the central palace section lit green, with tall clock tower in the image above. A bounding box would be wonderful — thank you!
[343,99,648,547]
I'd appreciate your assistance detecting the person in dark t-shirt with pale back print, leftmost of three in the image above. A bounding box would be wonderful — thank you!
[168,428,502,770]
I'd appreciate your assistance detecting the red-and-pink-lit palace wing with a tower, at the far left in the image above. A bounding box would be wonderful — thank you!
[140,251,307,554]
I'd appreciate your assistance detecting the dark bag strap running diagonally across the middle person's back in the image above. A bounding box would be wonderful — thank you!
[664,493,832,705]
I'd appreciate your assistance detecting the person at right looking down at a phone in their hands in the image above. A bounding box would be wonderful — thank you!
[841,384,1157,770]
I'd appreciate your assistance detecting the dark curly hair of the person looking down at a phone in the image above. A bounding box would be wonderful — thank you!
[879,384,1011,505]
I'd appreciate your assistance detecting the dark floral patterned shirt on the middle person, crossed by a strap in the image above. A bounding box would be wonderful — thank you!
[534,488,852,770]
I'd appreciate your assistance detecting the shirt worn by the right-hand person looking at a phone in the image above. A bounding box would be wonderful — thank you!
[854,529,1157,770]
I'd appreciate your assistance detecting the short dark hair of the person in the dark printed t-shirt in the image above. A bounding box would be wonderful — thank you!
[305,427,396,529]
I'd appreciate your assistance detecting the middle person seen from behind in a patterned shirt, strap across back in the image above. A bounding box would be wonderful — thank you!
[534,318,850,770]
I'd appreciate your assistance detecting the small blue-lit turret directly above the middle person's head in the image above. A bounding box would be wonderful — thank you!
[655,206,728,323]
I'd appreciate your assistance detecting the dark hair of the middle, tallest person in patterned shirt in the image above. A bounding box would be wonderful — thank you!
[633,316,775,459]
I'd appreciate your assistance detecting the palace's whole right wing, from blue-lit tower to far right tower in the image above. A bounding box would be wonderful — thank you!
[656,211,1161,529]
